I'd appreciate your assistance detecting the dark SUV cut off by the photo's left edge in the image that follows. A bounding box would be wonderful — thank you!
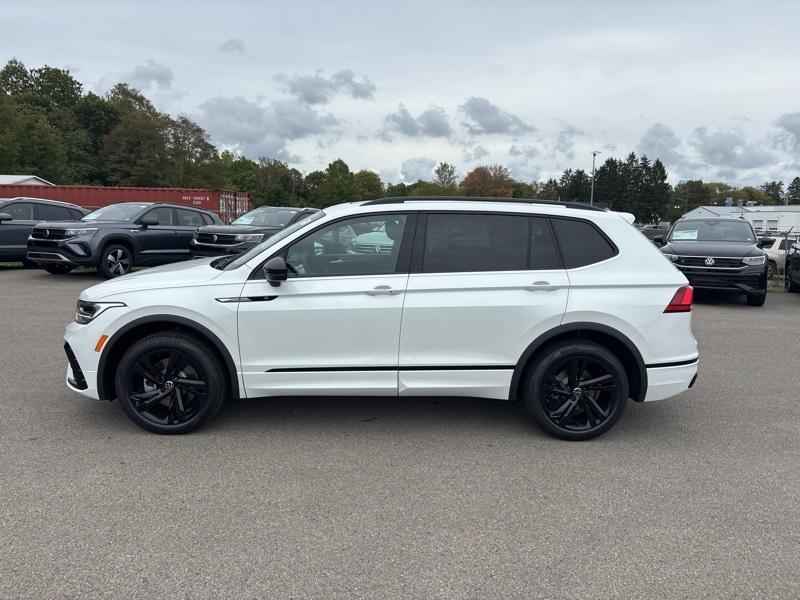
[0,198,89,264]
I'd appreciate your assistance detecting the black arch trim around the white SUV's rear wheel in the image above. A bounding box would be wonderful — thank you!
[509,322,647,402]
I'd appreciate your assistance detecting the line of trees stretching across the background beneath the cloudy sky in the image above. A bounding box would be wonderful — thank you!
[0,59,800,223]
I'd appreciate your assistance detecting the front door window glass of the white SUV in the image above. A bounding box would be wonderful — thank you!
[284,214,407,278]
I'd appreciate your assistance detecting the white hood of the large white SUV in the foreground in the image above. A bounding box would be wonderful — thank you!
[81,257,222,300]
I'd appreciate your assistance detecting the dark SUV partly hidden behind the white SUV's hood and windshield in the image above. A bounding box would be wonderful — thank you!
[192,206,318,256]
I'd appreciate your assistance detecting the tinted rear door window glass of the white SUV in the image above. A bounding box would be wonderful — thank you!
[422,213,528,273]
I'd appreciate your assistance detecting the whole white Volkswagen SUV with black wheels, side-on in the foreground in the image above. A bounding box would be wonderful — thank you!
[65,198,698,440]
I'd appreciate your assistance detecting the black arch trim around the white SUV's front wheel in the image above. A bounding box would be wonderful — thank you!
[97,315,239,400]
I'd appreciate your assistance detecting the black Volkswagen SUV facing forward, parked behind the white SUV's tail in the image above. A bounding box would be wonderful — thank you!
[653,218,767,306]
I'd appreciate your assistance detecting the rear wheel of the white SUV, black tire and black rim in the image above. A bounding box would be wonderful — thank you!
[523,339,628,441]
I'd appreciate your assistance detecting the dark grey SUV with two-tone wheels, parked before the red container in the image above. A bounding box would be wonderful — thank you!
[28,202,221,279]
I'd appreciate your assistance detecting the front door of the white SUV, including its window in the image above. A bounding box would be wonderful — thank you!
[239,213,415,397]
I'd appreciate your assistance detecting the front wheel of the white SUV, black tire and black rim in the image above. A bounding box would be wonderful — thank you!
[114,332,228,434]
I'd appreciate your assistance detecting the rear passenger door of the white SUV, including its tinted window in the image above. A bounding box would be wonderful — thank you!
[399,212,569,398]
